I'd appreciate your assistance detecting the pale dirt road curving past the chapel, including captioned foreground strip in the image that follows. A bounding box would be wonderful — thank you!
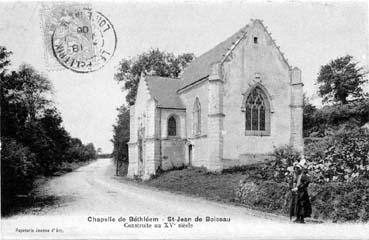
[1,159,369,239]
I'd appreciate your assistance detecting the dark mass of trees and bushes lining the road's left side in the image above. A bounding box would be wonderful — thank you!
[0,47,96,213]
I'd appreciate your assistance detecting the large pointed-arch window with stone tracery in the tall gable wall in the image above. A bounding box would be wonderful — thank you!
[243,87,270,135]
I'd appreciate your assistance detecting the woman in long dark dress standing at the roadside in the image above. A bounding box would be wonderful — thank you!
[290,164,311,223]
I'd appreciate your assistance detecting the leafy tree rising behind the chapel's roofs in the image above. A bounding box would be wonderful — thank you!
[114,49,194,103]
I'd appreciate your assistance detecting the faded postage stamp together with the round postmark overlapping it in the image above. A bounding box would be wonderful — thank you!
[41,5,117,73]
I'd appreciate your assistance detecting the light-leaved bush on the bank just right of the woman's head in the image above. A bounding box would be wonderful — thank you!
[305,130,369,183]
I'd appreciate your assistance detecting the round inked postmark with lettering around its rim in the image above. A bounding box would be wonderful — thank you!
[51,8,117,73]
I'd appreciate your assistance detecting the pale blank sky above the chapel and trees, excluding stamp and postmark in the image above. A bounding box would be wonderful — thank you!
[0,0,369,153]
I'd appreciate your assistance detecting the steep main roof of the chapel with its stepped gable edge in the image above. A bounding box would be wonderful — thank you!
[181,19,289,89]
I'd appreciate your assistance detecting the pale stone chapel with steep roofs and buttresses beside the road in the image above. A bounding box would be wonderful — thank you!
[128,20,303,179]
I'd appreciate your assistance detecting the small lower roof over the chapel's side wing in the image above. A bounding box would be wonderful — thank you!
[145,76,185,109]
